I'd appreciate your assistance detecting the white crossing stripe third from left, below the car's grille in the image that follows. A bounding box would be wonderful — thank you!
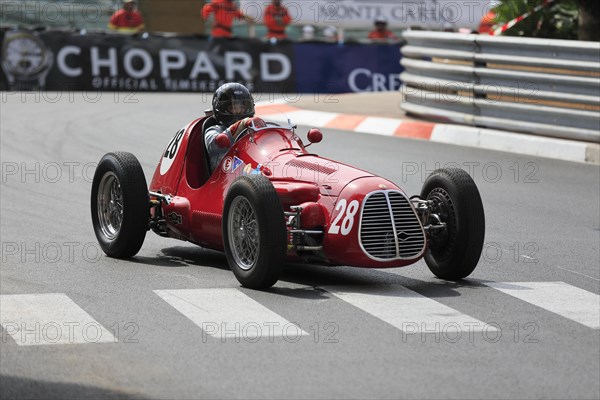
[323,285,497,333]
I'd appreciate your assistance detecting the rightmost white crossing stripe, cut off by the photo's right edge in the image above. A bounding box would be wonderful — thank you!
[486,282,600,329]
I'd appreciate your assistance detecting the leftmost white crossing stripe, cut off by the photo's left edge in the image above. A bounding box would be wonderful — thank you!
[0,293,117,346]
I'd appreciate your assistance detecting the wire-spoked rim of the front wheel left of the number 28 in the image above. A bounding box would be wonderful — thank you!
[227,196,260,271]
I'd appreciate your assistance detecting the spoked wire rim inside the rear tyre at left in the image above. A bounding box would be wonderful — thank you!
[97,172,123,240]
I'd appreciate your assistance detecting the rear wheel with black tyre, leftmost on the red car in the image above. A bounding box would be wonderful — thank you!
[91,152,150,258]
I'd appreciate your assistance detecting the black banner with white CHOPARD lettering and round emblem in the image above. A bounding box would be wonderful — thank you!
[1,31,296,92]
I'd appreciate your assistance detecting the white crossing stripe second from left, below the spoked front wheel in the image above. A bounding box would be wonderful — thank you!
[154,288,308,341]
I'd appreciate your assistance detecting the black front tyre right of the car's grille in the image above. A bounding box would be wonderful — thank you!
[421,168,485,281]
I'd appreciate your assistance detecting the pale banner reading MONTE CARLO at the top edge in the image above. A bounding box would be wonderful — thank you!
[240,0,494,30]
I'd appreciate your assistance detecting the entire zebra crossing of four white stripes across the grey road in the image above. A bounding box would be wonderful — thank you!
[0,282,600,346]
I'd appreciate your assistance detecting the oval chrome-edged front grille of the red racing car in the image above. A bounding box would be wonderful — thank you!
[359,190,425,261]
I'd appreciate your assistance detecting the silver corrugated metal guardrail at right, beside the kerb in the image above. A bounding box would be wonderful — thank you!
[400,31,600,142]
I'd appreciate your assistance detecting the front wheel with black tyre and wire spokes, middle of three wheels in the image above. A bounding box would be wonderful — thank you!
[222,175,287,289]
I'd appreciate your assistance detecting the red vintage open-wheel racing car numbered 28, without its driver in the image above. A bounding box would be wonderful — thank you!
[91,115,485,289]
